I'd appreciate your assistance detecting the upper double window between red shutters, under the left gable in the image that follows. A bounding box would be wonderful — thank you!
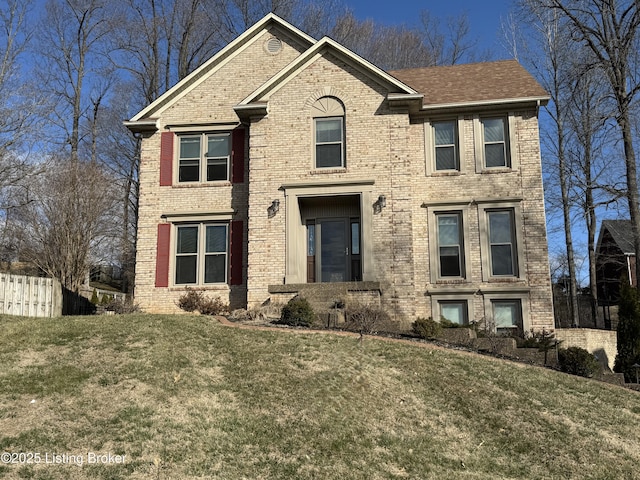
[178,133,231,182]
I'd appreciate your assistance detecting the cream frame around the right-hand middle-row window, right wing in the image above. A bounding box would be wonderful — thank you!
[478,202,525,282]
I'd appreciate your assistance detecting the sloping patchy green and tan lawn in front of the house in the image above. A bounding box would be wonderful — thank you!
[0,315,640,480]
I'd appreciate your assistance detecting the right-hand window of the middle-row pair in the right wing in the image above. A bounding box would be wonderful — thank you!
[487,209,518,276]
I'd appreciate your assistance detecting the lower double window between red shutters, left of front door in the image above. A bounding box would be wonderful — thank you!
[175,223,229,285]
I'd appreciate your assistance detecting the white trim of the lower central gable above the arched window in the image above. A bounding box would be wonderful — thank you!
[239,37,421,106]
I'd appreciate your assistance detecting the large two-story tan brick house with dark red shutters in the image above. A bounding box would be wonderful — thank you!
[126,14,553,331]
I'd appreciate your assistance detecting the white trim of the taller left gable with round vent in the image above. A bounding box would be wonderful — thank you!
[131,13,316,122]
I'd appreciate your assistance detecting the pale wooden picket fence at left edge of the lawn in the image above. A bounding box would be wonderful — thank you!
[0,273,62,317]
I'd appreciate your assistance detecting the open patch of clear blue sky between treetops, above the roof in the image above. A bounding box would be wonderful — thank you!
[344,0,513,58]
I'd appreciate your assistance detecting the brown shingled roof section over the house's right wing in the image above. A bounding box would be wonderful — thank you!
[389,60,549,108]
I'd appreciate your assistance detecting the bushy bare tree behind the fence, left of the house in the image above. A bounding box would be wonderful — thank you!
[9,159,114,292]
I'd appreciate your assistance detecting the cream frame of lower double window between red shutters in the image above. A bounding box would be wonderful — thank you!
[169,217,231,288]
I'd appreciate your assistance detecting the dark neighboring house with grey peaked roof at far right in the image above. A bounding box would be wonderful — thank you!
[596,220,636,306]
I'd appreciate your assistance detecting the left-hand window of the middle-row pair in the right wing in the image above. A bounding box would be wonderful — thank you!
[436,212,464,277]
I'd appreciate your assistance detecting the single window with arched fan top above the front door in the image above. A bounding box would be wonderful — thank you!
[312,97,345,168]
